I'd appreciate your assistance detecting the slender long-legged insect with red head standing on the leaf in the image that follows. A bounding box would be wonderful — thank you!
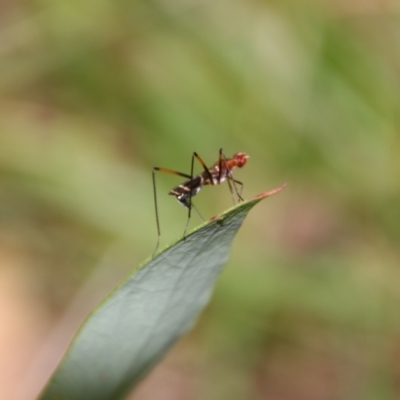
[153,149,249,253]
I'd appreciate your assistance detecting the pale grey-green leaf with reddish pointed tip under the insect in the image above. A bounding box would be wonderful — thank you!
[41,185,285,400]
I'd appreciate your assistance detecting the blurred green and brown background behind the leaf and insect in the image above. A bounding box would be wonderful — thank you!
[0,0,400,400]
